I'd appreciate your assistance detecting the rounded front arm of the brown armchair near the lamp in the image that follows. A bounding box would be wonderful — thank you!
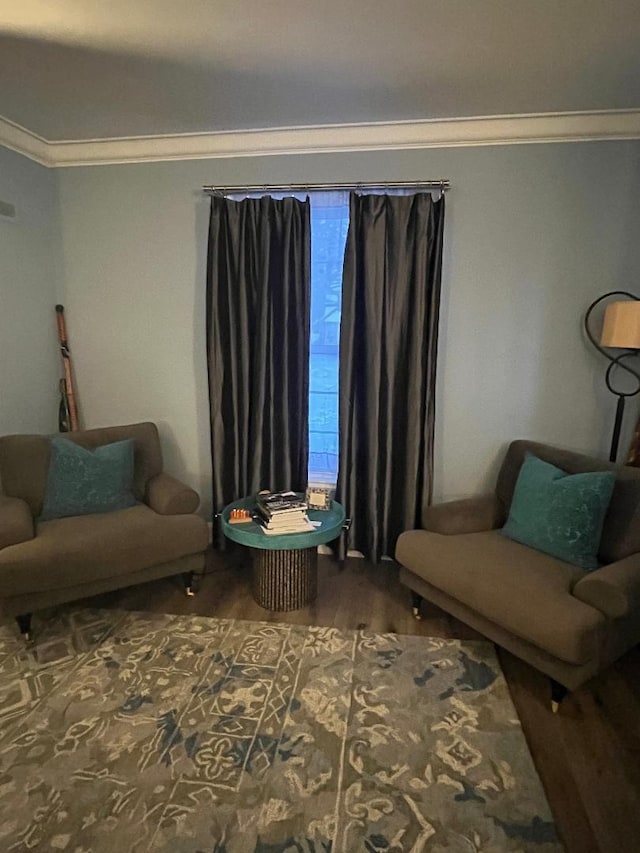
[572,554,640,619]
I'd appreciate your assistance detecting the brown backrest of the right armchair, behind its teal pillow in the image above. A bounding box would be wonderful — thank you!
[496,440,640,563]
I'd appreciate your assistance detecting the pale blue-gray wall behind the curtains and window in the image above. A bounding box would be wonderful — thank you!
[59,142,640,512]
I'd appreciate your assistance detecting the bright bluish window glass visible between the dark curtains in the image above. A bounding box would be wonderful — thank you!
[309,192,349,483]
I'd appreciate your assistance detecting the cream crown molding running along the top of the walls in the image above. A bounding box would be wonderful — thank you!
[0,110,640,168]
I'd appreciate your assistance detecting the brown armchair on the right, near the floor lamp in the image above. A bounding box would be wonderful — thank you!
[396,441,640,690]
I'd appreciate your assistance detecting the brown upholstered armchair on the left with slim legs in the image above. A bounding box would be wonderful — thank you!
[0,423,209,634]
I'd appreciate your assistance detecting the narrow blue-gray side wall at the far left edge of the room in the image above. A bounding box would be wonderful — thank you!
[0,147,61,435]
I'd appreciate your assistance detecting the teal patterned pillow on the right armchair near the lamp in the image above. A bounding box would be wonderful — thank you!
[502,454,615,569]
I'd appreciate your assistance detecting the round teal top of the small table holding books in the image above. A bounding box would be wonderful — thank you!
[222,497,345,551]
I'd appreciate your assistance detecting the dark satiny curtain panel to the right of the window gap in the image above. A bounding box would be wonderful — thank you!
[336,193,444,562]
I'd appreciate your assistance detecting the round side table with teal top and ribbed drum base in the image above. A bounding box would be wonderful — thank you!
[222,497,345,611]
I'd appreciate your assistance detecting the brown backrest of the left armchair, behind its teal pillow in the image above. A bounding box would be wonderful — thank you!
[0,423,162,517]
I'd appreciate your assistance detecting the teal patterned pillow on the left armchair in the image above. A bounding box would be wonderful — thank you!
[40,436,136,521]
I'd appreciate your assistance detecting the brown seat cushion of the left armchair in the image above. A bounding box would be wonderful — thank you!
[0,505,209,596]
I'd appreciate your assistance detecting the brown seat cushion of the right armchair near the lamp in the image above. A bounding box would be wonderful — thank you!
[396,530,605,665]
